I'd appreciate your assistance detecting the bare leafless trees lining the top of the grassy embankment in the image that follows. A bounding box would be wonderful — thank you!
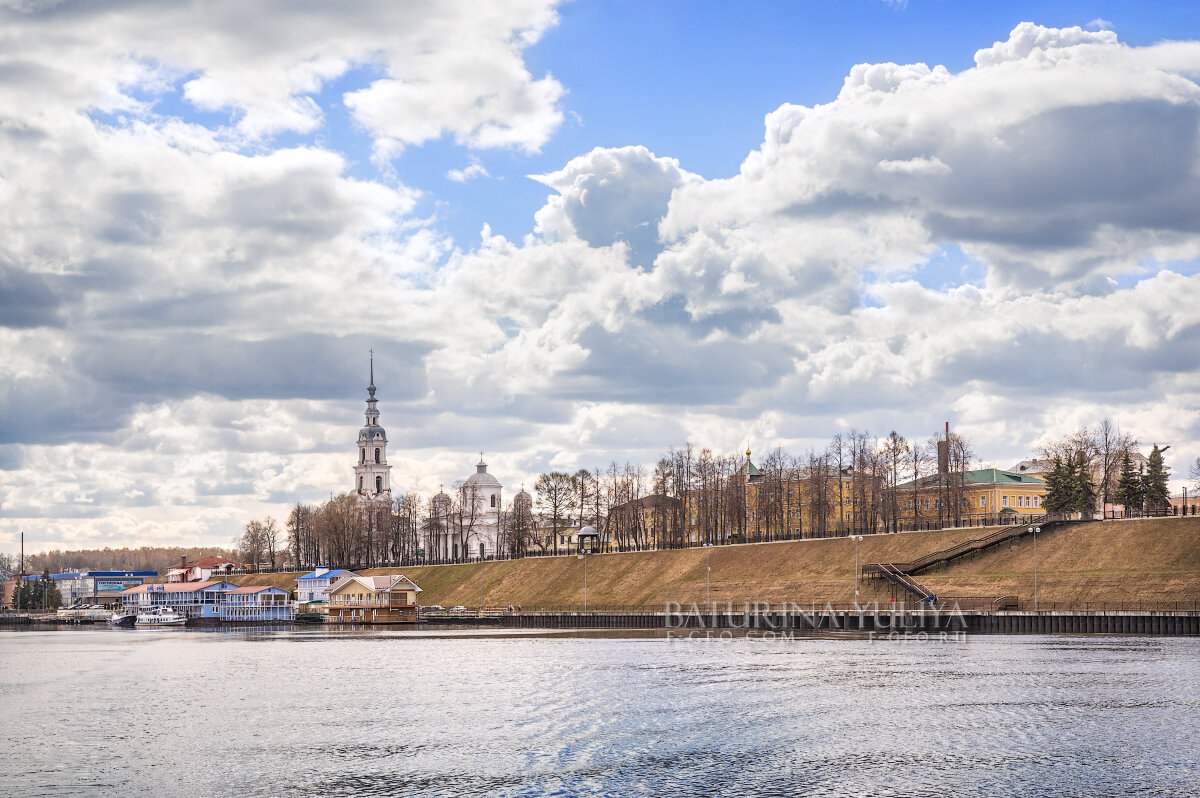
[231,419,1152,568]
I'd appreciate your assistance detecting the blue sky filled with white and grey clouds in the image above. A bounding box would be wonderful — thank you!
[0,0,1200,551]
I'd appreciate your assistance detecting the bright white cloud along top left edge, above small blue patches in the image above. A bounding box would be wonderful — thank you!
[0,0,563,148]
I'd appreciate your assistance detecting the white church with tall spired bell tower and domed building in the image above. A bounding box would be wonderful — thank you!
[354,352,511,562]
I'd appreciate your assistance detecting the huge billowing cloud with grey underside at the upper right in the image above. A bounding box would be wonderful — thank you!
[662,23,1200,296]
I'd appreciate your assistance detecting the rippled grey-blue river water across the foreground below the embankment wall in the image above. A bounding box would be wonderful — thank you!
[0,628,1200,798]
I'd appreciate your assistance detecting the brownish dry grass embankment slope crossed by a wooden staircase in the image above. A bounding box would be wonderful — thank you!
[232,517,1200,610]
